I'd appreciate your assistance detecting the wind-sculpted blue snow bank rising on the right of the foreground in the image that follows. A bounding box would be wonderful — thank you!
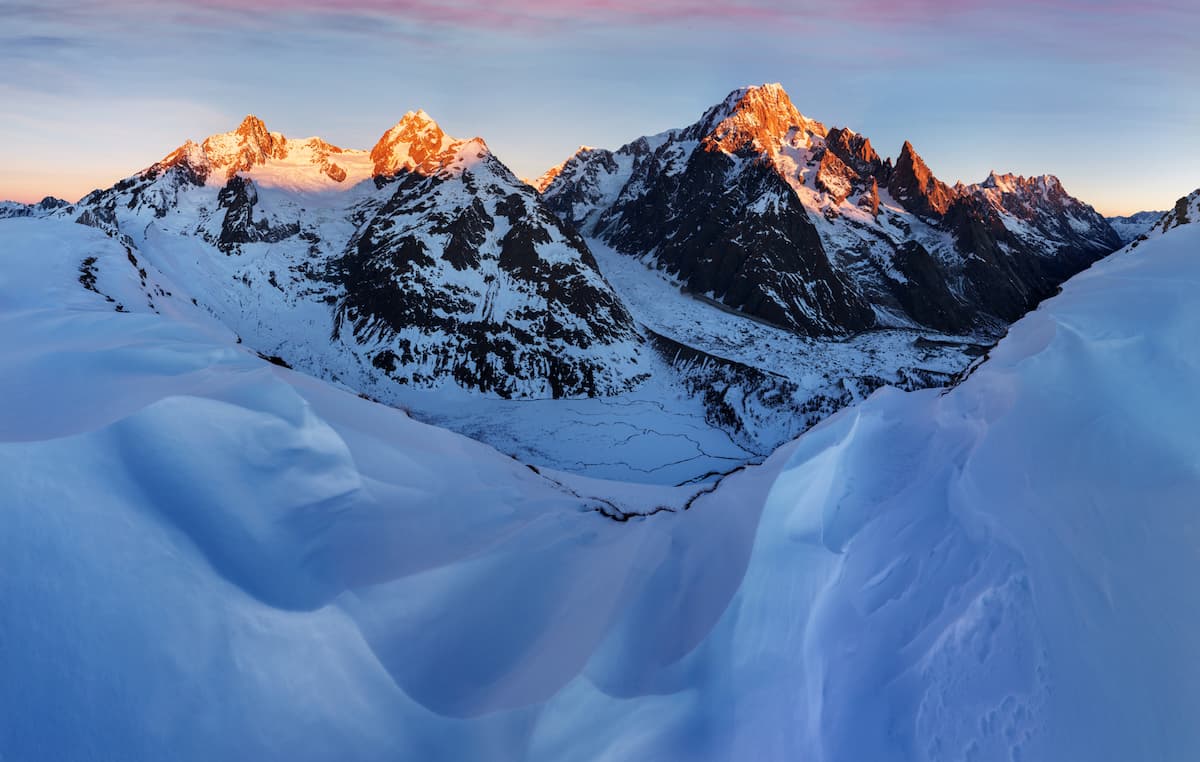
[745,210,1200,760]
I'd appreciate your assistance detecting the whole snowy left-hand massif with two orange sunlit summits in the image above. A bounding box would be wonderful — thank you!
[62,112,646,398]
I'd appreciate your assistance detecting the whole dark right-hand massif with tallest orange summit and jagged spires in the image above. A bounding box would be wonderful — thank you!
[542,85,1121,336]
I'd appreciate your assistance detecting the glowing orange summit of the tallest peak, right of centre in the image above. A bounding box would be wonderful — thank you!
[696,83,827,154]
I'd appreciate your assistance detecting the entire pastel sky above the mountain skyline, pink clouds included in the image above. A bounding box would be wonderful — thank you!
[0,0,1200,214]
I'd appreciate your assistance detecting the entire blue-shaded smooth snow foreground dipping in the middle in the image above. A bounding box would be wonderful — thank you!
[0,221,1200,761]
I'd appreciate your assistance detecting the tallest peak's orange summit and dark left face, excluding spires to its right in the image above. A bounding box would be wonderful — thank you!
[545,86,875,336]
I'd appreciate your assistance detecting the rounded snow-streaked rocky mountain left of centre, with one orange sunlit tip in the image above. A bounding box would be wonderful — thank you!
[331,120,640,397]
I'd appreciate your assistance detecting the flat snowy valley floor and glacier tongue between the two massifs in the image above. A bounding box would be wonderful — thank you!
[389,240,990,485]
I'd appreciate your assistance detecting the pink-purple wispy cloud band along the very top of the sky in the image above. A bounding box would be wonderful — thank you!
[23,0,1185,60]
